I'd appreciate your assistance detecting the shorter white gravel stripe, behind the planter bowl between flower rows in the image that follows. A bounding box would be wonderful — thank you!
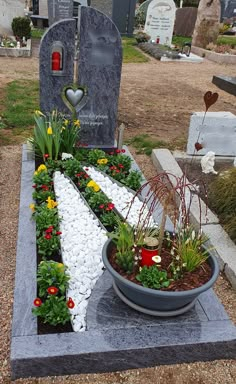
[84,167,155,226]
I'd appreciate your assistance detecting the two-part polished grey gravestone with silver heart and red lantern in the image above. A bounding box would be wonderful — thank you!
[40,6,122,148]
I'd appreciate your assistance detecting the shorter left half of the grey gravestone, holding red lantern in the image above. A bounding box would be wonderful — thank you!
[39,19,76,114]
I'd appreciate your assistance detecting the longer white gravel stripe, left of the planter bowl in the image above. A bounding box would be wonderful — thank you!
[54,172,107,332]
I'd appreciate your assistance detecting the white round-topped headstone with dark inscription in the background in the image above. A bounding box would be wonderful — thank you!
[144,0,176,46]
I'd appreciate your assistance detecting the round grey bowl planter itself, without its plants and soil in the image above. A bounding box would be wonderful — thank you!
[102,239,219,316]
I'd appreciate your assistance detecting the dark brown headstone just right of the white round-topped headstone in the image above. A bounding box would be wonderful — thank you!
[174,7,197,37]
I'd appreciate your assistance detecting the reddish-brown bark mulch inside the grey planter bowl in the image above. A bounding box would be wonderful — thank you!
[109,243,212,292]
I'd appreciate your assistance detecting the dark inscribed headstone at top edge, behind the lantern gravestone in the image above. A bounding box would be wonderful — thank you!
[48,0,73,25]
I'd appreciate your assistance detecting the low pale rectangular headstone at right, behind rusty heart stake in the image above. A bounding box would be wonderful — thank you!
[187,112,236,156]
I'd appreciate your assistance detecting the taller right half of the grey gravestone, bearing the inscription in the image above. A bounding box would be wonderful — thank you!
[77,7,122,147]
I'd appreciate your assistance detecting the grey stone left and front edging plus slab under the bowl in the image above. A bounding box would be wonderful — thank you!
[11,147,236,379]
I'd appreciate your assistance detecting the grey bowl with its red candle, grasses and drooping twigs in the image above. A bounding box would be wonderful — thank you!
[103,173,219,316]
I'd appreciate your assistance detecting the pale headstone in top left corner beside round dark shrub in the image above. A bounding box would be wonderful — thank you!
[0,0,25,36]
